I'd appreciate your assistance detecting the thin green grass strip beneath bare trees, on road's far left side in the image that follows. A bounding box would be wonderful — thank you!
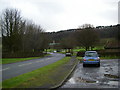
[0,54,49,64]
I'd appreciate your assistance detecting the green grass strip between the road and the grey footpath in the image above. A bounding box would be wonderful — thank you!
[2,57,70,88]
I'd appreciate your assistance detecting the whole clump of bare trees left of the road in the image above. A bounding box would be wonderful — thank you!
[0,9,49,57]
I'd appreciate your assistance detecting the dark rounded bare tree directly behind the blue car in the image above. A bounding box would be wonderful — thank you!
[76,24,99,51]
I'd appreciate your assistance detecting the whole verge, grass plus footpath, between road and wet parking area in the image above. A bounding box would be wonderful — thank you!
[2,57,79,88]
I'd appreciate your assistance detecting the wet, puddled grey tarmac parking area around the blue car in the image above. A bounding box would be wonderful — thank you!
[60,59,120,88]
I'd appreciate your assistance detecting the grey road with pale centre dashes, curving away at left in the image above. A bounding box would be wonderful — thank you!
[0,53,65,81]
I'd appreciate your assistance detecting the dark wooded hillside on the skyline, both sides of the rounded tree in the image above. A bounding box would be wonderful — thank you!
[48,24,120,42]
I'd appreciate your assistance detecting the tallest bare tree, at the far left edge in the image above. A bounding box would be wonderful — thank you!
[1,9,24,53]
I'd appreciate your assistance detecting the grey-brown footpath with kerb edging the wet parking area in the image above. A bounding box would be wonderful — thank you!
[49,56,78,89]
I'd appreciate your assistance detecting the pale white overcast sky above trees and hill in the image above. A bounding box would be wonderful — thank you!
[0,0,119,32]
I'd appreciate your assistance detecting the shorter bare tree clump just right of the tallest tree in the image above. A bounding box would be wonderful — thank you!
[23,22,49,52]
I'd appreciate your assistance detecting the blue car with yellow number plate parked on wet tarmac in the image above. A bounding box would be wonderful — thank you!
[83,51,100,67]
